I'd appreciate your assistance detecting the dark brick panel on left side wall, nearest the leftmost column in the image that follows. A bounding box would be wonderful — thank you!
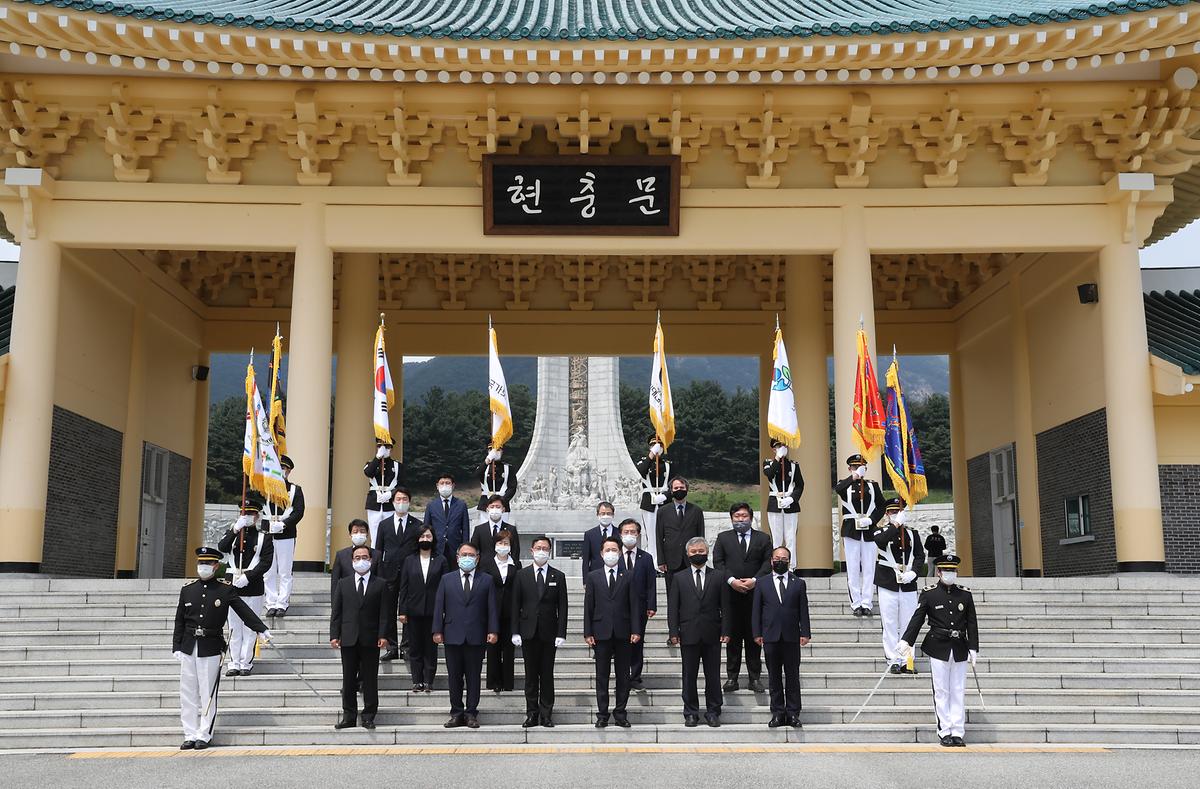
[41,405,121,578]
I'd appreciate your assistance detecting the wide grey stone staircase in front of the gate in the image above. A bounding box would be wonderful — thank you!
[0,576,1200,749]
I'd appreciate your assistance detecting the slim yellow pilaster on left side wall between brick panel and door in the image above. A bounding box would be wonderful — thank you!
[116,291,146,578]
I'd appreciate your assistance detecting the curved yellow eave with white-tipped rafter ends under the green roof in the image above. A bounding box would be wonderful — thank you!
[0,0,1200,84]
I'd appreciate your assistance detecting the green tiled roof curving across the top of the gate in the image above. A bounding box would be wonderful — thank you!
[18,0,1194,41]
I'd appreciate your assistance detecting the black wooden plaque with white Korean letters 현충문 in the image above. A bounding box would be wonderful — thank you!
[484,153,679,235]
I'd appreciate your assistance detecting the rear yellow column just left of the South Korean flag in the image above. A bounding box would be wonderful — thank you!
[330,253,376,552]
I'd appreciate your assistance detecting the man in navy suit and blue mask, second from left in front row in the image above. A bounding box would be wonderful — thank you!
[433,543,500,729]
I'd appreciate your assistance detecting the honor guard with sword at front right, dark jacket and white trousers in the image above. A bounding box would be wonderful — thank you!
[900,554,979,748]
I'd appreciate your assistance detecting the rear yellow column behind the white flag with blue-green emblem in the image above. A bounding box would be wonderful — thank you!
[784,257,833,577]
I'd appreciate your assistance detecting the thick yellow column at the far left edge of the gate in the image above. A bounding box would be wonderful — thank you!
[0,233,62,572]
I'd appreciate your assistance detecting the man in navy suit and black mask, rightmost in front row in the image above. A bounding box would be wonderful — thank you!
[750,546,812,729]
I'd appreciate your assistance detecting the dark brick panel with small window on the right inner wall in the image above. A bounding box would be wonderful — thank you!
[1037,409,1117,577]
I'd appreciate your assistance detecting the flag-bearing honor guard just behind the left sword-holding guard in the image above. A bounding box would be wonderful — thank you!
[217,501,275,676]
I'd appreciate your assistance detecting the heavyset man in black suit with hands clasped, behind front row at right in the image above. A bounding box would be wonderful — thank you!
[713,501,770,693]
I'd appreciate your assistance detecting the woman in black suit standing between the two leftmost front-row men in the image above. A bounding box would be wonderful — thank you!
[397,526,446,693]
